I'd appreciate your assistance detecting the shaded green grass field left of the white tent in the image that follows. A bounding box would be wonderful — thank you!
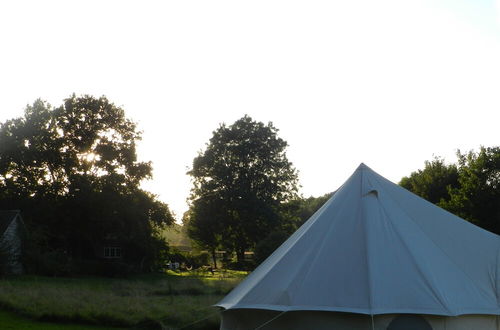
[0,271,246,330]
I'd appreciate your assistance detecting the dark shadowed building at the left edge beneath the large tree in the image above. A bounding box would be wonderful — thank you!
[0,210,26,274]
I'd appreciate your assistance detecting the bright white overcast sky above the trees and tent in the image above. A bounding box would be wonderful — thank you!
[0,0,500,220]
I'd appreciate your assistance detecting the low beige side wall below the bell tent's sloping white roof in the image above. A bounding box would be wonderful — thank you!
[220,309,500,330]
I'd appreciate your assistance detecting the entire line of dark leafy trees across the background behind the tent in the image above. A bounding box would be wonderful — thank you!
[0,95,500,275]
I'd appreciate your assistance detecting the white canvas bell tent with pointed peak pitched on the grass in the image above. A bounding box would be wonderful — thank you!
[216,164,500,330]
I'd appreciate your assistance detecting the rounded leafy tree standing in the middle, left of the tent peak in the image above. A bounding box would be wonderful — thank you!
[188,116,298,262]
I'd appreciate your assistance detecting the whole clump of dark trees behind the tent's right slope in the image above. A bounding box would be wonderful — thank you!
[400,147,500,234]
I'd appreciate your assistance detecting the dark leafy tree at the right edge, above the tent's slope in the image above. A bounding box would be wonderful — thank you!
[441,147,500,234]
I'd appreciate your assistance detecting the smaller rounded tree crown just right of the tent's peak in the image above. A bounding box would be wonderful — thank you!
[399,157,459,204]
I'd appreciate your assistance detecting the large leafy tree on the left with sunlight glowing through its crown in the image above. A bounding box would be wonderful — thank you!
[0,95,173,268]
